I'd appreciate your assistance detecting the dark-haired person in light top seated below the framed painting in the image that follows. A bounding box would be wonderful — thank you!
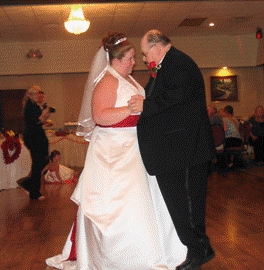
[223,105,244,168]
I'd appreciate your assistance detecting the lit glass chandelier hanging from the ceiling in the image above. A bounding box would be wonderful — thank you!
[64,5,90,35]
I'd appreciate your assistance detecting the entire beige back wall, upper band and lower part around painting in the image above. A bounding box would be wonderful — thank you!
[0,35,264,128]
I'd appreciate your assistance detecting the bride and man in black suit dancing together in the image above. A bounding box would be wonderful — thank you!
[46,30,214,270]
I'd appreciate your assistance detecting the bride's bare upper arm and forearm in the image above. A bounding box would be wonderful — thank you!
[92,74,131,126]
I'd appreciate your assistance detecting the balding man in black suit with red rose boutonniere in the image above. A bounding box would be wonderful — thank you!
[129,30,214,270]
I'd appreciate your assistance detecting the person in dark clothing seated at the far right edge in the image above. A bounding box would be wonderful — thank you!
[249,106,264,165]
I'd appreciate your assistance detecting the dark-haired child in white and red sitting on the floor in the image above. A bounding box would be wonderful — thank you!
[41,150,77,184]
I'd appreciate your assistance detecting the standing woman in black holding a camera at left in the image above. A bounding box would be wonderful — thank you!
[20,85,50,200]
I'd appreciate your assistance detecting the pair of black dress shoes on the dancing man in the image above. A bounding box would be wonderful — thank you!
[175,246,215,270]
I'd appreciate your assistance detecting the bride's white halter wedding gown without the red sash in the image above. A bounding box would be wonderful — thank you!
[46,67,187,270]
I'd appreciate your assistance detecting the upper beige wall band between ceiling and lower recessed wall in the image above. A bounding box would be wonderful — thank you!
[0,35,264,75]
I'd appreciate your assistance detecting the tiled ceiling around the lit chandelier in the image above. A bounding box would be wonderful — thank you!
[0,0,264,42]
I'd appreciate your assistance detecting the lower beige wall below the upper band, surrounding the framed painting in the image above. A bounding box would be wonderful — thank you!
[0,67,264,128]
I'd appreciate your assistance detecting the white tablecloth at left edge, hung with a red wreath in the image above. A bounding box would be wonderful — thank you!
[0,141,31,190]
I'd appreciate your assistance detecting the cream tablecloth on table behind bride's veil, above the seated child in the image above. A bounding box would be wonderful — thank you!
[48,134,89,167]
